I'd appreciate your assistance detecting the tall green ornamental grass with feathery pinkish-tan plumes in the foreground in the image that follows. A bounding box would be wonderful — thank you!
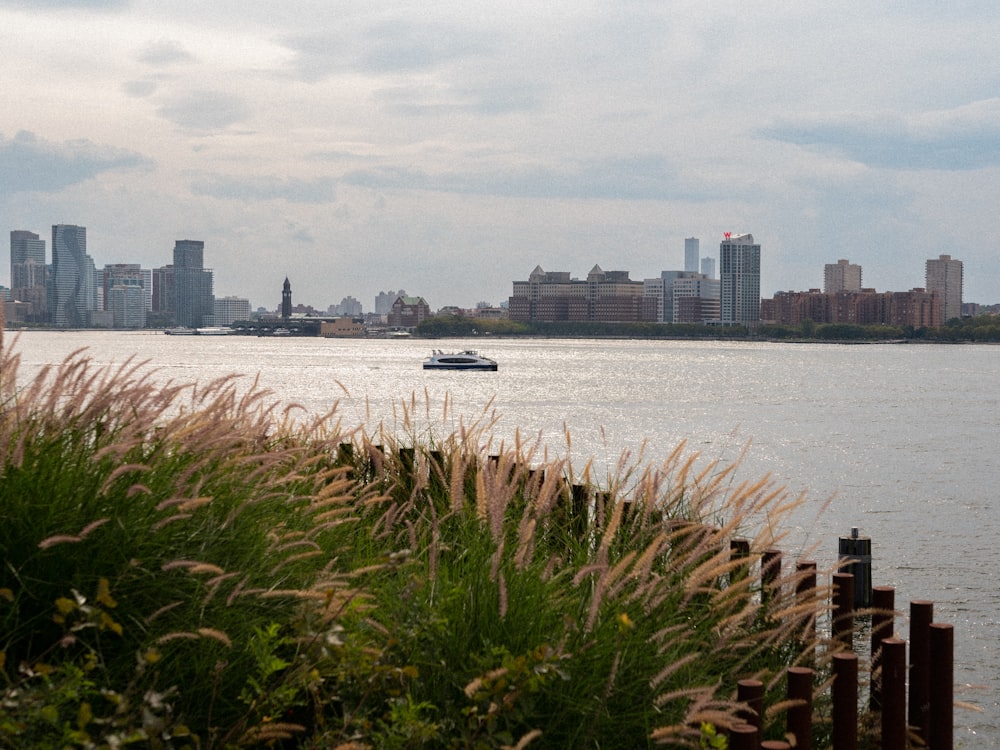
[0,338,835,748]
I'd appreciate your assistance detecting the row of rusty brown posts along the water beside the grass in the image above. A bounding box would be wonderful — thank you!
[341,446,954,750]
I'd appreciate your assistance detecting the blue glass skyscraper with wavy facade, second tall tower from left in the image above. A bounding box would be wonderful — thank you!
[51,224,97,327]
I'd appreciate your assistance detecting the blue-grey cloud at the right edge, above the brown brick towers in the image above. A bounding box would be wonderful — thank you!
[759,99,1000,170]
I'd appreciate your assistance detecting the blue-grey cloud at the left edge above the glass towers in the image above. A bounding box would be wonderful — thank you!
[0,130,152,194]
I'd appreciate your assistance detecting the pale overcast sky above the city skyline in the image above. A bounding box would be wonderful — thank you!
[0,0,1000,311]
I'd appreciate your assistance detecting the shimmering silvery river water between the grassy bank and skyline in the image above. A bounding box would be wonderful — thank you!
[6,331,1000,748]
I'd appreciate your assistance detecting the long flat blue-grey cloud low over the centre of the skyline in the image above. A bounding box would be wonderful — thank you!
[344,154,707,201]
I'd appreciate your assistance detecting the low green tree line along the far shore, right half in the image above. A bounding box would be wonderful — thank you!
[416,315,1000,342]
